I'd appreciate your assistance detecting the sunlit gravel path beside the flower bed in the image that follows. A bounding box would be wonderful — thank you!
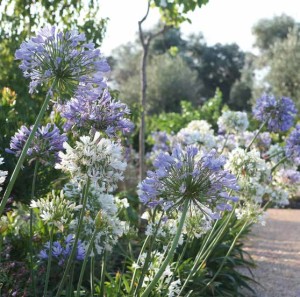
[241,209,300,297]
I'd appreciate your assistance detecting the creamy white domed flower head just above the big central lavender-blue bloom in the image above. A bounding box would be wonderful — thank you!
[174,120,216,149]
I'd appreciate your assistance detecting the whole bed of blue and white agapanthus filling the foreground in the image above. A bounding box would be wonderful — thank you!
[0,27,300,297]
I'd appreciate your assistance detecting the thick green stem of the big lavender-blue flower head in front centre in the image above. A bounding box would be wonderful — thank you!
[141,199,190,297]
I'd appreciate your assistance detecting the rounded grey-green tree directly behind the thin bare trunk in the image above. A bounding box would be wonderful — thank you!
[112,45,200,115]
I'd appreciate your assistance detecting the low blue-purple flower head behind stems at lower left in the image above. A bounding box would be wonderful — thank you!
[38,234,86,266]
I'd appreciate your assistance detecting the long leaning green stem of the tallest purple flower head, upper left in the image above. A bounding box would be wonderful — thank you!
[0,80,57,216]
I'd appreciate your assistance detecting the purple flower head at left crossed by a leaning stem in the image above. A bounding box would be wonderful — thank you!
[6,123,67,165]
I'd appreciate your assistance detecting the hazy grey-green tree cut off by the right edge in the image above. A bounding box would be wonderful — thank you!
[253,15,300,107]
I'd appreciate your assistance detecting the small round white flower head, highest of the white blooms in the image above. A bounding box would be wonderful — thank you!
[218,110,249,133]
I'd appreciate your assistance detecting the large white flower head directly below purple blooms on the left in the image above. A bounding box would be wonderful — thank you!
[56,132,126,192]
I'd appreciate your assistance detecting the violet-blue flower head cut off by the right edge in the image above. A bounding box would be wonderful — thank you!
[285,124,300,165]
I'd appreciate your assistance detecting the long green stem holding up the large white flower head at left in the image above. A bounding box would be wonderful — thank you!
[55,180,90,297]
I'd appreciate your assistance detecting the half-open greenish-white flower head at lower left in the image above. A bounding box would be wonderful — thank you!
[30,191,81,231]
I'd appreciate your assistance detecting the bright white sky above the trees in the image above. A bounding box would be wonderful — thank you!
[98,0,300,55]
